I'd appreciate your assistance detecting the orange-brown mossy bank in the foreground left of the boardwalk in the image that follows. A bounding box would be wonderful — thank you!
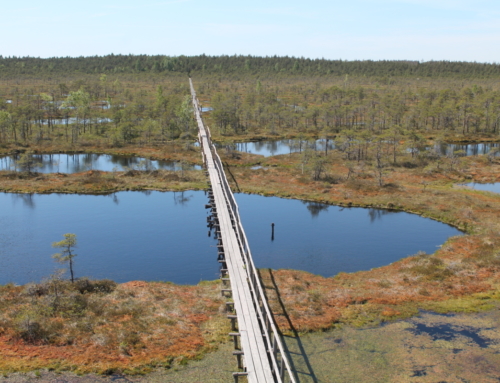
[0,281,229,373]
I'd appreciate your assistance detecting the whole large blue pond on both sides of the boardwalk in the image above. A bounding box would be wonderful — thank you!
[0,191,459,284]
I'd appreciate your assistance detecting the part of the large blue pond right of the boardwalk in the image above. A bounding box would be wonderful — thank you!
[236,194,460,276]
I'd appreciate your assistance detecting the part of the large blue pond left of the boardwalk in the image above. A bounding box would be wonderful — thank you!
[0,191,219,284]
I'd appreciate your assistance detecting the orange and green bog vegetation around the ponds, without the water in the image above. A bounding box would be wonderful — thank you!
[0,55,500,372]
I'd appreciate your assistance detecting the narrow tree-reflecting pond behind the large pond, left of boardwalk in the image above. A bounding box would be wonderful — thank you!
[0,154,201,173]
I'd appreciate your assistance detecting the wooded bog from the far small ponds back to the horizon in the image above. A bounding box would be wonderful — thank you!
[0,55,500,148]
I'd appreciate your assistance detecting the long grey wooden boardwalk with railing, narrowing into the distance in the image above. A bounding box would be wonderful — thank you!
[189,79,295,383]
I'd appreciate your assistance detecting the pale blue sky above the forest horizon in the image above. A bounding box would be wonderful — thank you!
[0,0,500,62]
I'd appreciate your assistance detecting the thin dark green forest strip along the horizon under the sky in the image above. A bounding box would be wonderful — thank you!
[0,54,500,79]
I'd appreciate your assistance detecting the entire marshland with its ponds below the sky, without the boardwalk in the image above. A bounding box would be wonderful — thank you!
[0,56,500,382]
